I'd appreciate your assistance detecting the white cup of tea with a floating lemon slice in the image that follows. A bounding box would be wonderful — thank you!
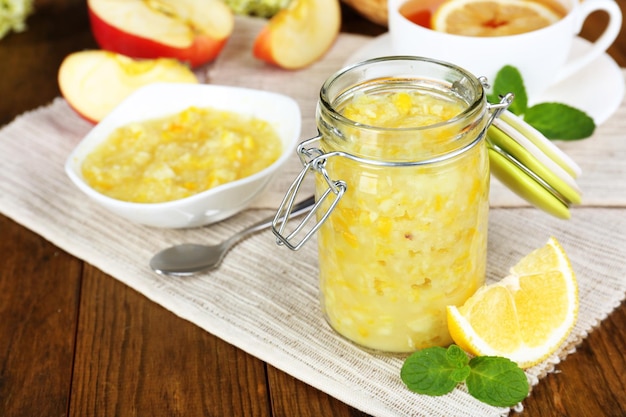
[388,0,622,100]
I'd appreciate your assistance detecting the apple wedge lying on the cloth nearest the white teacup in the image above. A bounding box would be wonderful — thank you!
[253,0,341,69]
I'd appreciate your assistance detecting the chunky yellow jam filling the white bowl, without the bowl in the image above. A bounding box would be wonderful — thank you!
[81,106,282,203]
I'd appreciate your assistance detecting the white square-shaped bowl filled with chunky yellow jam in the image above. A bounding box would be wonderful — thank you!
[65,84,301,228]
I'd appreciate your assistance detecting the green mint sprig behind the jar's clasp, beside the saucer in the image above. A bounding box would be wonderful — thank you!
[488,65,596,140]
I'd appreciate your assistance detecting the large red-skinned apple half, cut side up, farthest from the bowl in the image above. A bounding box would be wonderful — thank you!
[87,0,234,67]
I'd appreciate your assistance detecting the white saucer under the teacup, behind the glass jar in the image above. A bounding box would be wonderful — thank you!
[346,33,624,125]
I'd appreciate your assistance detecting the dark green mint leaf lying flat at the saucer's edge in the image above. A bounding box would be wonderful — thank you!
[524,103,596,140]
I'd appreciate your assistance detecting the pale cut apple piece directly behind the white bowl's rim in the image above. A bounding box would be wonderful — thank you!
[58,50,198,123]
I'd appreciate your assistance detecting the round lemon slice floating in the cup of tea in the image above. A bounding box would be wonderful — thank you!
[431,0,561,36]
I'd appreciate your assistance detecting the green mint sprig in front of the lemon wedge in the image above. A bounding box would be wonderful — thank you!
[400,344,529,407]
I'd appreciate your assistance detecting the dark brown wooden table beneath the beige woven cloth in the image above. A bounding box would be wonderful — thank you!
[0,0,626,417]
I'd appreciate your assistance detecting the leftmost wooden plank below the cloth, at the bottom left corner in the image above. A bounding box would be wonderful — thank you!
[0,216,83,417]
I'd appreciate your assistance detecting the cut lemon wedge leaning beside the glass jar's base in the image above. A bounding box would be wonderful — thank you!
[447,238,578,368]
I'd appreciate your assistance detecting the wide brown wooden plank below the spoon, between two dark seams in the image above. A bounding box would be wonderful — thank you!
[70,265,270,417]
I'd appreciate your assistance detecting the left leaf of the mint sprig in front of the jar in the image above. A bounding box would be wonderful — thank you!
[400,346,470,396]
